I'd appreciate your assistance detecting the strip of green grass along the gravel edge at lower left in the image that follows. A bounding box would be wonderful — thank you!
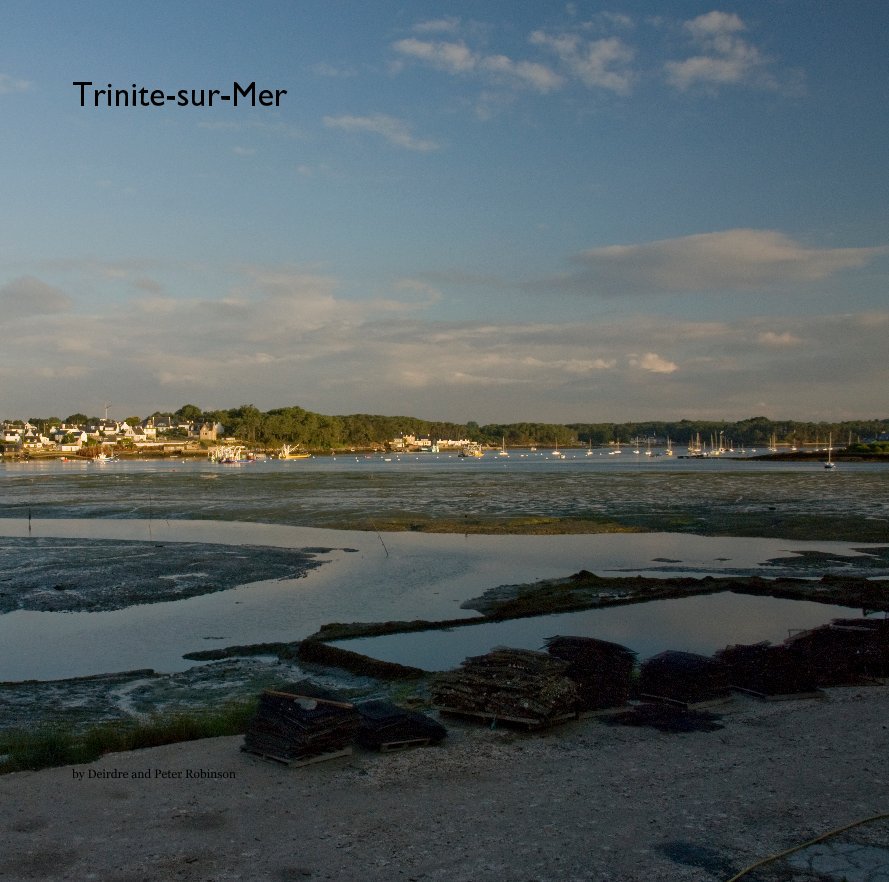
[0,698,257,774]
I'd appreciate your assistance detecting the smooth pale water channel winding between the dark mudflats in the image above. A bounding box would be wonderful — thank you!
[0,508,879,680]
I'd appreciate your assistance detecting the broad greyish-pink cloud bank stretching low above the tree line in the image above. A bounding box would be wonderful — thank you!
[0,265,889,422]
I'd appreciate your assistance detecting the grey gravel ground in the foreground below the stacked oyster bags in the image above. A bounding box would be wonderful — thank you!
[0,685,889,882]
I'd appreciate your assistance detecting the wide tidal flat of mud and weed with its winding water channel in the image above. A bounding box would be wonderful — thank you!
[0,456,889,725]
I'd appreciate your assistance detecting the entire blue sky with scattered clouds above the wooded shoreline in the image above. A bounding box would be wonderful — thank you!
[0,0,889,424]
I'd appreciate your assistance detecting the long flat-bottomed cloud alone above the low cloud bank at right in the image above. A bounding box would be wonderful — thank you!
[573,229,887,294]
